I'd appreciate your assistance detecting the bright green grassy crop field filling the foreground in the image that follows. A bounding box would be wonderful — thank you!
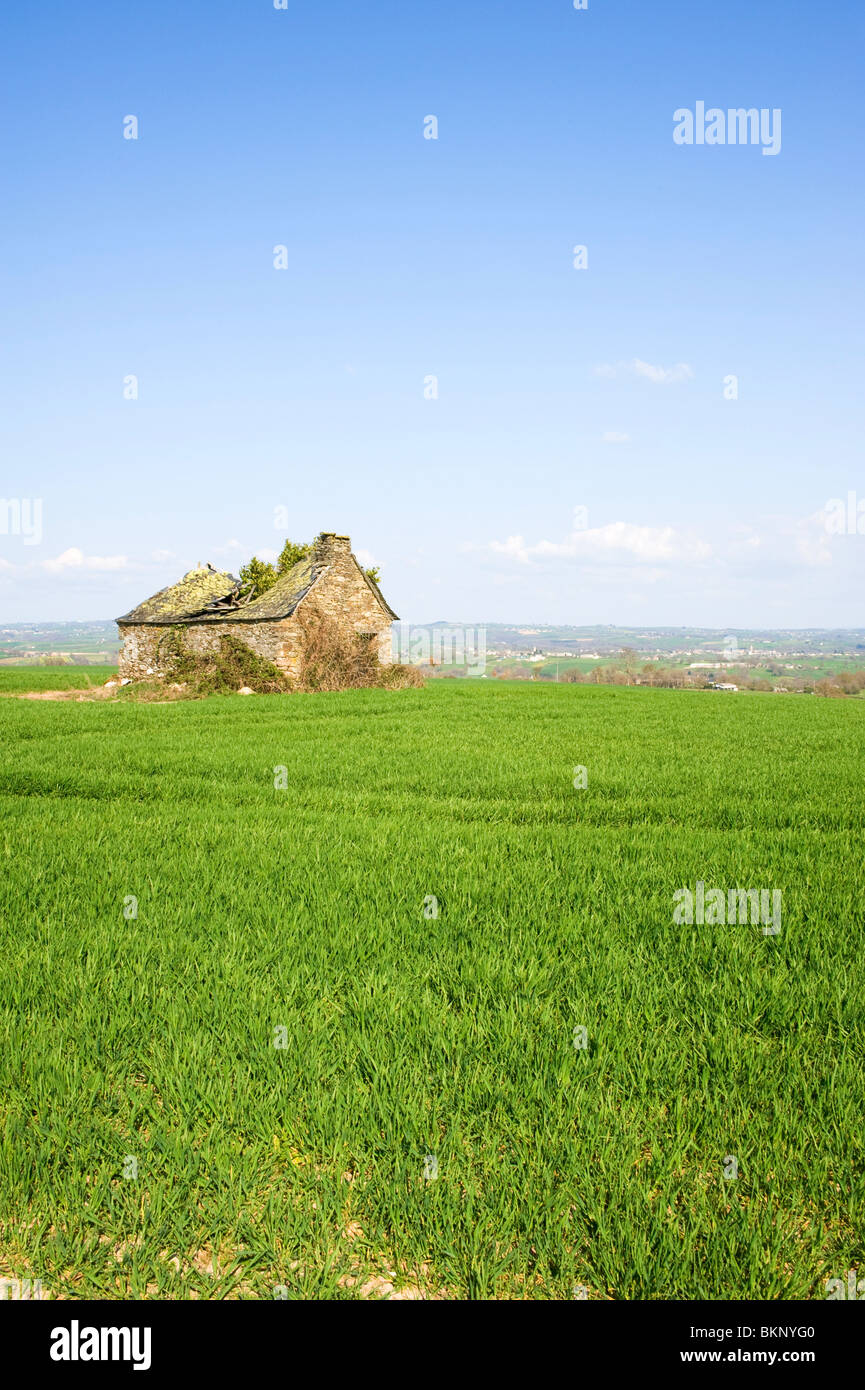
[0,670,865,1300]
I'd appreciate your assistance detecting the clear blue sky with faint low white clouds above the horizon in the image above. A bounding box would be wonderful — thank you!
[0,0,865,628]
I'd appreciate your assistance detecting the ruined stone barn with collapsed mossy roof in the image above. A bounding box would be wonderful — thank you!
[117,532,398,680]
